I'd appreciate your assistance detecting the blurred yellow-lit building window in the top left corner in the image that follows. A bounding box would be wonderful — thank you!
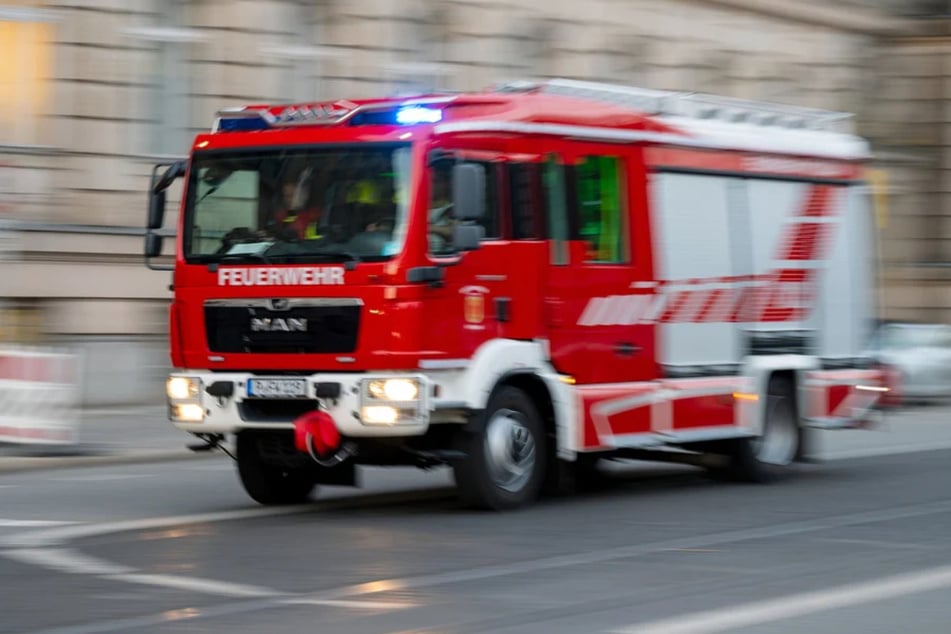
[0,0,54,145]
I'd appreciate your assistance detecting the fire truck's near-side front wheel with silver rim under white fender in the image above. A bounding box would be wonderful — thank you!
[453,386,548,511]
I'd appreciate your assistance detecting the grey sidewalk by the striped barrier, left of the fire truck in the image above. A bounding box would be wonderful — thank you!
[0,405,216,473]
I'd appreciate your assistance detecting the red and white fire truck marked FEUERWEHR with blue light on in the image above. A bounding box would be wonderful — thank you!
[145,79,889,509]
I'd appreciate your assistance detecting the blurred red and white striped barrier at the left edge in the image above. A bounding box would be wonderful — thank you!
[0,347,81,445]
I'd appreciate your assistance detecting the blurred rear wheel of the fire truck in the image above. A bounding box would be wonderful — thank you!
[728,377,804,483]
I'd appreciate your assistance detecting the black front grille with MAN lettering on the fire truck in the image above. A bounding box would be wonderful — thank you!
[205,300,362,353]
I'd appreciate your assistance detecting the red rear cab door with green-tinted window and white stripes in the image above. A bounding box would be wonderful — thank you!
[543,142,658,385]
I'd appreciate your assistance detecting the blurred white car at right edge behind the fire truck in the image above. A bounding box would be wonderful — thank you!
[868,323,951,403]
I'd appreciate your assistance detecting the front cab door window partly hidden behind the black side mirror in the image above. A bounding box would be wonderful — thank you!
[427,160,501,255]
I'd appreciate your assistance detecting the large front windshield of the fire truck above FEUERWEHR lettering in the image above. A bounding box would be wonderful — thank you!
[184,145,410,262]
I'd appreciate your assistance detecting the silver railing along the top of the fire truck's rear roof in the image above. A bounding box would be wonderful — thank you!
[493,79,854,134]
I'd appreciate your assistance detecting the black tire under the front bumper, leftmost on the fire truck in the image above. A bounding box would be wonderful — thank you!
[236,432,316,506]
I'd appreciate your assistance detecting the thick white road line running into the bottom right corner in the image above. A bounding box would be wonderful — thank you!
[614,566,951,634]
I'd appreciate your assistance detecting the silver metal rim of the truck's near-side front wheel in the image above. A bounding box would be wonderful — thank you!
[485,409,535,493]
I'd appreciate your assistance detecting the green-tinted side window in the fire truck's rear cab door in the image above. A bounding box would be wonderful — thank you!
[575,156,628,263]
